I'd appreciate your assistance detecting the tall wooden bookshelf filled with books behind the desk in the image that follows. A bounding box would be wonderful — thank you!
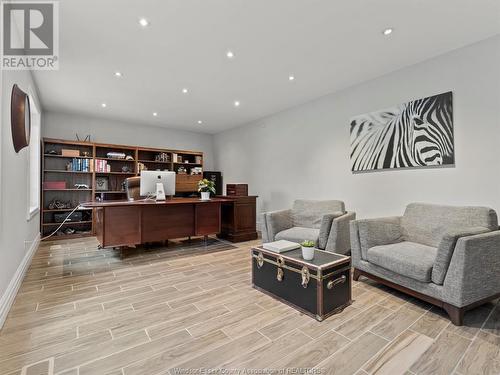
[40,138,203,239]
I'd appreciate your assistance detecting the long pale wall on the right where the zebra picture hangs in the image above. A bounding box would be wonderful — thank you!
[214,36,500,218]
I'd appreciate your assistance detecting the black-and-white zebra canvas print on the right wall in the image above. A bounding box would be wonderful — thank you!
[350,91,455,172]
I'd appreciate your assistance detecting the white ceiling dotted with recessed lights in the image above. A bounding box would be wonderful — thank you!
[35,0,500,133]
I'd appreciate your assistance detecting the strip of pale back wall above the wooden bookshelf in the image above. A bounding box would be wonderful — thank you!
[42,111,213,170]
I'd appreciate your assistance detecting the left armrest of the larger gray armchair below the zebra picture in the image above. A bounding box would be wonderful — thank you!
[356,216,404,260]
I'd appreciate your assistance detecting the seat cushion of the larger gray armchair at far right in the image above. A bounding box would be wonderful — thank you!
[367,241,437,283]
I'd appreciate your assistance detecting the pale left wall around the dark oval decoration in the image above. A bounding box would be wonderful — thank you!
[0,67,41,320]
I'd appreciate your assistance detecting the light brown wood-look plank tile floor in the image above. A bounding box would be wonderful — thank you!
[0,238,500,375]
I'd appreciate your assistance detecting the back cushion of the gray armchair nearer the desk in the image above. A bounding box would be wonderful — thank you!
[292,199,345,229]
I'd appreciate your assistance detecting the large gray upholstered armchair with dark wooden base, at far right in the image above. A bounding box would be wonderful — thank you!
[350,203,500,325]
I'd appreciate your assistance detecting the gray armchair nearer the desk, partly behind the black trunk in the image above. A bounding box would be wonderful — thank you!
[261,200,356,254]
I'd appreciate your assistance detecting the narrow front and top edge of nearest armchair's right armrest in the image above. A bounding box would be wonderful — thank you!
[432,227,490,285]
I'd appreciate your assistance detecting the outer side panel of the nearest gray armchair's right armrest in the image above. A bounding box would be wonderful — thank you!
[443,230,500,307]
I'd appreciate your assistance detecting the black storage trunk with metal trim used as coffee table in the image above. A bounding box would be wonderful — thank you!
[251,247,351,321]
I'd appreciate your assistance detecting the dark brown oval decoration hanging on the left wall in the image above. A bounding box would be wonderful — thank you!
[10,84,31,153]
